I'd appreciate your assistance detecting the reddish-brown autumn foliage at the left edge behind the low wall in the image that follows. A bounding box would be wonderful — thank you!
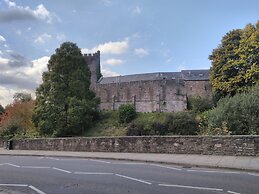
[0,100,38,138]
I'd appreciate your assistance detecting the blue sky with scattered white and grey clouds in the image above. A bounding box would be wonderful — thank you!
[0,0,259,106]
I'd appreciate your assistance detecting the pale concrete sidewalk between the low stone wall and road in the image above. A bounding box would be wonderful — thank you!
[0,149,259,172]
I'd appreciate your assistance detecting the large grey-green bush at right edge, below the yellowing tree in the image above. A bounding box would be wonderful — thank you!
[208,85,259,135]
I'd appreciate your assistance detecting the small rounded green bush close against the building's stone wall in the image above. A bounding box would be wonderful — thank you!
[119,104,137,123]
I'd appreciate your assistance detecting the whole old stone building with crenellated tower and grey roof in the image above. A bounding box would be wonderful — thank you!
[84,51,212,112]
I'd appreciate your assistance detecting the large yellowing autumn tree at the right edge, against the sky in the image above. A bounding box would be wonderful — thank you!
[209,21,259,99]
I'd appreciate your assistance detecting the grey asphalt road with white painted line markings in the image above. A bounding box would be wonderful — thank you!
[0,156,259,194]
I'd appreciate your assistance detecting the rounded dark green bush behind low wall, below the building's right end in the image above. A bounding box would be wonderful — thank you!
[166,111,199,135]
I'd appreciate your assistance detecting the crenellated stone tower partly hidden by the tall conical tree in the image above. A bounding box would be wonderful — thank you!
[84,51,102,90]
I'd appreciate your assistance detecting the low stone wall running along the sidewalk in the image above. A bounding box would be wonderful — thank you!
[12,136,259,156]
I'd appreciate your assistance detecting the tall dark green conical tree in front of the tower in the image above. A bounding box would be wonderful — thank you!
[33,42,99,136]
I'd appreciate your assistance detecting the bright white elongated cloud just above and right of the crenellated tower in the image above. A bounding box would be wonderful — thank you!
[82,39,129,54]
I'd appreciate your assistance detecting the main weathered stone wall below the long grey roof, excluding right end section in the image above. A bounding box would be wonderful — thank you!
[96,80,190,112]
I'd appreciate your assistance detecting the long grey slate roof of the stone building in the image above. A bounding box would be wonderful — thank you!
[99,70,209,84]
